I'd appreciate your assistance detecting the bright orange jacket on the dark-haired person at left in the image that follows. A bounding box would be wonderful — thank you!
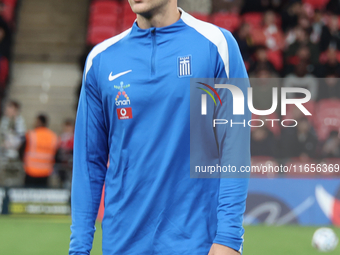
[24,127,58,178]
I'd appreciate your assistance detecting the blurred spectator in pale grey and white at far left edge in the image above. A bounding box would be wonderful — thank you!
[0,101,26,160]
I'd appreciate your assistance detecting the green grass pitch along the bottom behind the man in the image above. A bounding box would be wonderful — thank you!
[0,216,340,255]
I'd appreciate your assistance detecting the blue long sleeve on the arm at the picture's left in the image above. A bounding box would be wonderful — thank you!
[69,56,109,255]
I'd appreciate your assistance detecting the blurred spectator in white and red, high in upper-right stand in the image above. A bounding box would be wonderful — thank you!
[263,11,284,51]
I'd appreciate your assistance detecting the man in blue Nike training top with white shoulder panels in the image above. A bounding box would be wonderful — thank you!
[69,0,250,255]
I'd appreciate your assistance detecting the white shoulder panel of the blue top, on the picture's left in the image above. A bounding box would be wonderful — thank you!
[85,28,131,78]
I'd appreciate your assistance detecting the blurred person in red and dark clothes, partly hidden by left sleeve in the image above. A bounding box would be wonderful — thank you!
[56,120,74,188]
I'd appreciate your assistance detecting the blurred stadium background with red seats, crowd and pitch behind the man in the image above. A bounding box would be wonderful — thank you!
[0,0,340,255]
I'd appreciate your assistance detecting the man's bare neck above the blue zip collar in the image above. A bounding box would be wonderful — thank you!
[137,6,181,29]
